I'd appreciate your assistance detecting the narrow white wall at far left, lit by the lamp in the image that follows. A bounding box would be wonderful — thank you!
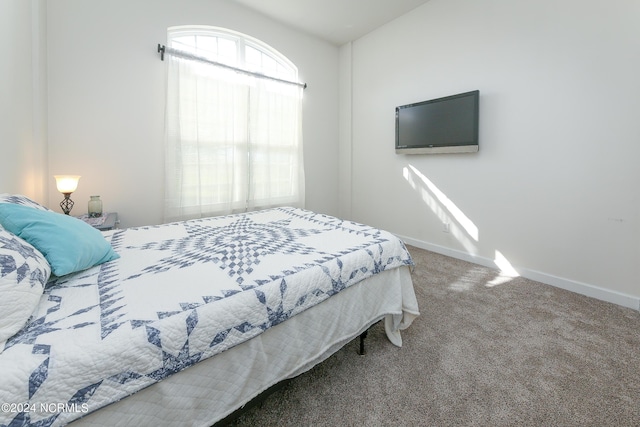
[0,0,47,203]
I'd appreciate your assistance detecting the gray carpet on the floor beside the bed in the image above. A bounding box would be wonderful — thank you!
[236,247,640,426]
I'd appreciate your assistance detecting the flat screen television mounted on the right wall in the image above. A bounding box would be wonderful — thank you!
[396,90,480,154]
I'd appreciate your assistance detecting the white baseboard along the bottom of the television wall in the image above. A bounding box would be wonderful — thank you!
[398,236,640,311]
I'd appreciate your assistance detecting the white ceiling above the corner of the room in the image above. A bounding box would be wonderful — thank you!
[235,0,429,46]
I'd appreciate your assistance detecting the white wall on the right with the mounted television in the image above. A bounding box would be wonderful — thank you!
[348,0,640,308]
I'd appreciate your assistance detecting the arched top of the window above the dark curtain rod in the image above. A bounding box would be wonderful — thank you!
[167,25,298,80]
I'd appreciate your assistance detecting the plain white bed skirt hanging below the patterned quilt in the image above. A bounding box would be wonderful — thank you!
[73,267,419,427]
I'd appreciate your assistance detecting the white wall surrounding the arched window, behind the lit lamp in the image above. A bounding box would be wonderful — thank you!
[47,0,339,227]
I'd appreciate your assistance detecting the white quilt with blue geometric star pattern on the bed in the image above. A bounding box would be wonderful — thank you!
[0,208,412,426]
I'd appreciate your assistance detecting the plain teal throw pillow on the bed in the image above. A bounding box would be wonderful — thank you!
[0,203,120,276]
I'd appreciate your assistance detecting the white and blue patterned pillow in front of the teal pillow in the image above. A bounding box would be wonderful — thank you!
[0,229,51,353]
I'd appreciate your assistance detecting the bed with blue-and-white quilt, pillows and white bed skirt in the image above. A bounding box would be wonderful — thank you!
[0,195,419,426]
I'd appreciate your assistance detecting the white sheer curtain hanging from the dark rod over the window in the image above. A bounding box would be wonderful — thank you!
[165,56,304,221]
